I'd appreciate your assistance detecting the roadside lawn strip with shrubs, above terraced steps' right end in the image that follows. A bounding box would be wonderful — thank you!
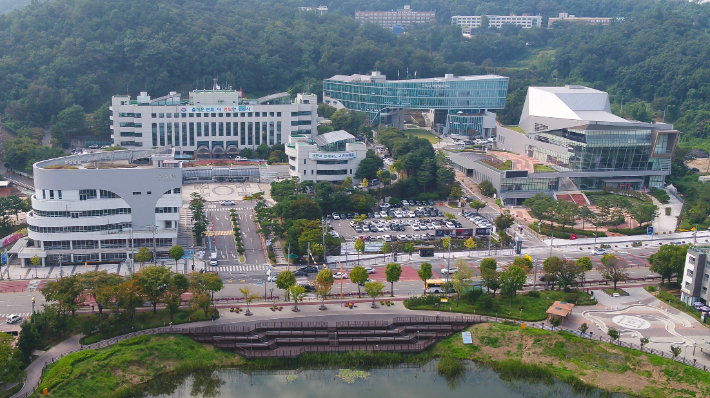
[407,290,596,322]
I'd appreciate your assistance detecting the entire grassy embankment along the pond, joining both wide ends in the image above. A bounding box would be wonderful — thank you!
[41,323,710,398]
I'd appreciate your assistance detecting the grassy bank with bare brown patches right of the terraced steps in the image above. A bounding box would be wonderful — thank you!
[430,323,710,398]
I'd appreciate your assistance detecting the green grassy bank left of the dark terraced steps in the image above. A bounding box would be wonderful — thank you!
[35,335,242,398]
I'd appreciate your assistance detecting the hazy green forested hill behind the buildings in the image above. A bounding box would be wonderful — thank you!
[0,0,710,148]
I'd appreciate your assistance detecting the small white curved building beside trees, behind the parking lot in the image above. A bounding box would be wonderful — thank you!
[286,130,367,182]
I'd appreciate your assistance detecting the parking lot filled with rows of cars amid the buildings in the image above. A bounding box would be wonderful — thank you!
[328,202,493,242]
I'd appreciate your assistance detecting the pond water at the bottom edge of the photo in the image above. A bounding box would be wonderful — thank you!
[136,361,626,398]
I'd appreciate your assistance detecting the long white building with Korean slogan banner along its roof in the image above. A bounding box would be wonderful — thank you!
[110,89,318,158]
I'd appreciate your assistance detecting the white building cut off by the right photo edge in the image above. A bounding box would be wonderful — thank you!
[680,246,710,305]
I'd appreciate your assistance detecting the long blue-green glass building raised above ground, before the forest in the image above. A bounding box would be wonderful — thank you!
[323,71,508,138]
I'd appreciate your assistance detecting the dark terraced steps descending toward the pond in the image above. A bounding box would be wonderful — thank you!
[176,316,486,358]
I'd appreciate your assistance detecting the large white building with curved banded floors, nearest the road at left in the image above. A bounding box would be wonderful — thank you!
[19,149,182,266]
